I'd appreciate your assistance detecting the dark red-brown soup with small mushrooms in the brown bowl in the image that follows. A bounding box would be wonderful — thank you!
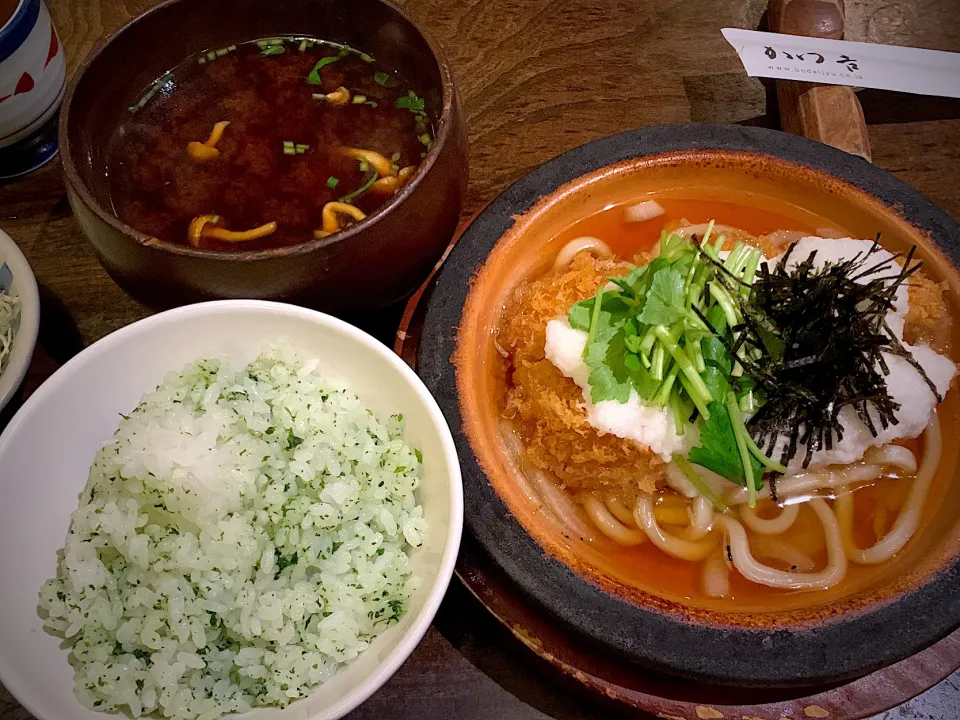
[107,37,434,251]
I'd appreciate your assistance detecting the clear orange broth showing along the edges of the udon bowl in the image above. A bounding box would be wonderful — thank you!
[502,194,958,612]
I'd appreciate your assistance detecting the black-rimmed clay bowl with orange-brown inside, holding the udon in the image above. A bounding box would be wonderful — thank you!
[417,125,960,686]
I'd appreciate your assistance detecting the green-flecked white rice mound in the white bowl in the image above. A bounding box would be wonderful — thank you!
[40,348,426,720]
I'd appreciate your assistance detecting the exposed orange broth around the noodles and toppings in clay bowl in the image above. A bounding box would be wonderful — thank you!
[493,192,960,612]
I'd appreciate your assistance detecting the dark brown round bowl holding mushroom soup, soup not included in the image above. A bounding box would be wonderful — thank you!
[60,0,467,311]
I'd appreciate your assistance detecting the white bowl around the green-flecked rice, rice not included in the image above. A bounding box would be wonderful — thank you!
[0,300,463,720]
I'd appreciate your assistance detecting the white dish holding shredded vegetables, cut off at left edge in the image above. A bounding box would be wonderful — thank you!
[0,230,40,410]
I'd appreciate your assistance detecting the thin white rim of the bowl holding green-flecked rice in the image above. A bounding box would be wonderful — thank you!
[0,300,463,720]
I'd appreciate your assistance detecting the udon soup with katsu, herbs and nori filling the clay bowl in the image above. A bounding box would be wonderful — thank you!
[496,199,957,611]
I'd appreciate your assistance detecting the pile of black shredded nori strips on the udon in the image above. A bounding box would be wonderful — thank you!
[703,235,942,467]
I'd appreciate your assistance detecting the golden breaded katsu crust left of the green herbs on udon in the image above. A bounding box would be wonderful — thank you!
[497,252,664,497]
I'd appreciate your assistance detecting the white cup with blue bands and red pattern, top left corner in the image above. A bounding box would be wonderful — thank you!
[0,0,66,179]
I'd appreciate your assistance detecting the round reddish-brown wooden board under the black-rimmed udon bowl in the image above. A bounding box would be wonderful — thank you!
[394,229,960,720]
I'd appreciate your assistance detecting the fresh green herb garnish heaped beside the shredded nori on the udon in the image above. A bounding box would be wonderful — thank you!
[568,224,782,496]
